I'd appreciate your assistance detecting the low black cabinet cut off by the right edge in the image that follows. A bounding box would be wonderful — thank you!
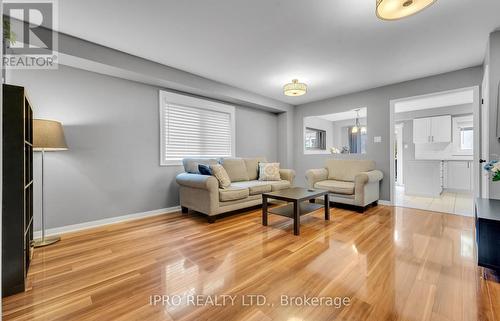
[475,198,500,272]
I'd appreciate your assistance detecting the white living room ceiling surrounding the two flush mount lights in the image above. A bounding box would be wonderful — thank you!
[54,0,500,104]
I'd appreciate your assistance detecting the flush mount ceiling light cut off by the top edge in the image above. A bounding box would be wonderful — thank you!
[377,0,437,20]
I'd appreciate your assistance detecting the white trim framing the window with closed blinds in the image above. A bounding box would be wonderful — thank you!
[159,90,236,166]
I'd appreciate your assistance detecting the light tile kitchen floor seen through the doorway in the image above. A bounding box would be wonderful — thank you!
[394,186,474,216]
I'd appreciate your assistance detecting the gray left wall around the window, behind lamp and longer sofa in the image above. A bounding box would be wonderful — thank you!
[7,66,278,229]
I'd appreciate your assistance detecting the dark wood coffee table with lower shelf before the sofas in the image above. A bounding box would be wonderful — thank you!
[262,187,330,235]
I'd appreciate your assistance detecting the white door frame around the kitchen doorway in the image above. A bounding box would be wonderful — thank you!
[389,86,482,204]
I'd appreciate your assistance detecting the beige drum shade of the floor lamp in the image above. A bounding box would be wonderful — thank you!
[33,119,68,151]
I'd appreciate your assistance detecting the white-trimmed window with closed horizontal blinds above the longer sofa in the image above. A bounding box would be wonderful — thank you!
[160,91,235,165]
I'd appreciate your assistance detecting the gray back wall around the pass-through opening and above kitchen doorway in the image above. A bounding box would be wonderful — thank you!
[294,67,482,200]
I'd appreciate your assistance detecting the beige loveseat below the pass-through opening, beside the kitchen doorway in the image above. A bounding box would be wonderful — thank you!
[306,159,384,212]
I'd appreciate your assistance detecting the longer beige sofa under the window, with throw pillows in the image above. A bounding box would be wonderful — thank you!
[177,158,295,223]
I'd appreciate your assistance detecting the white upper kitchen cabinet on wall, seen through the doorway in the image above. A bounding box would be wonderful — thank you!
[413,115,451,144]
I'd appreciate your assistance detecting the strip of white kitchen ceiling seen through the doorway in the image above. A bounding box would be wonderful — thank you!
[394,89,474,113]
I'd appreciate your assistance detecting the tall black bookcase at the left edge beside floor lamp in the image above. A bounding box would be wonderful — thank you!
[2,84,33,296]
